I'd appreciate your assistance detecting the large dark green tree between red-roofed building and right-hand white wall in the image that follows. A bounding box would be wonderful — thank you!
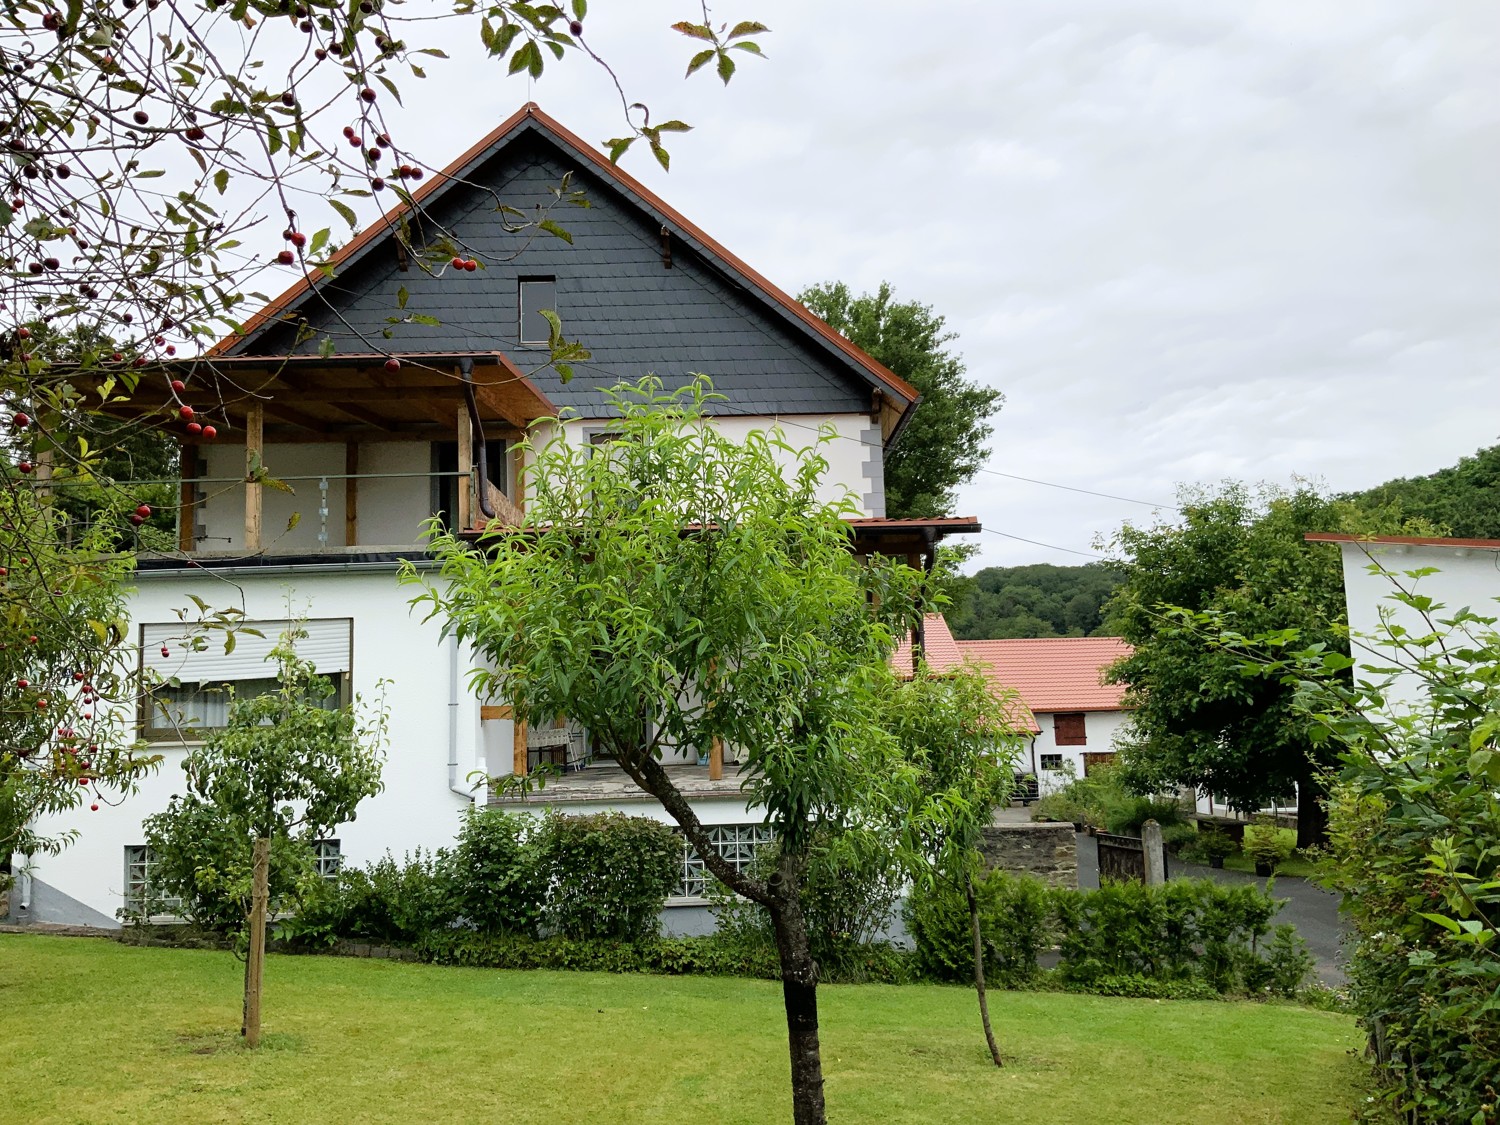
[1106,485,1398,848]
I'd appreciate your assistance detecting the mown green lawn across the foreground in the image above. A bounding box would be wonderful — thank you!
[0,935,1358,1125]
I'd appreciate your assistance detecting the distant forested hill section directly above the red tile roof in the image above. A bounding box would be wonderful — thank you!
[947,563,1119,641]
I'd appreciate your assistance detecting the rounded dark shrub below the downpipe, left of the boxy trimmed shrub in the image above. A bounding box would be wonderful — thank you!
[443,809,549,938]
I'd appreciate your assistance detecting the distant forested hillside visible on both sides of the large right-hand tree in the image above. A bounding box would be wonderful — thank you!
[947,446,1500,641]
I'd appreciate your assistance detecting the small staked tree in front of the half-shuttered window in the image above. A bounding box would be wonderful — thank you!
[165,627,386,1047]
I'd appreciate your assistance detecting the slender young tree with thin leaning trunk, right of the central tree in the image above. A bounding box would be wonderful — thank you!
[884,665,1026,1067]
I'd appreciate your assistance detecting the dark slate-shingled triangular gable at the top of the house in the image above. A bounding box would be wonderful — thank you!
[216,107,917,437]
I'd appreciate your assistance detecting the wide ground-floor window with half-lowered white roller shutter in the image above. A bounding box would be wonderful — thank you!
[140,618,354,741]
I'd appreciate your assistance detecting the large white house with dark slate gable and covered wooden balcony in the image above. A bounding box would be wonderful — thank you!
[12,105,978,926]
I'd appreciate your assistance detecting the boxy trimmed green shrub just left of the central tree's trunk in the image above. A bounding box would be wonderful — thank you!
[539,813,683,942]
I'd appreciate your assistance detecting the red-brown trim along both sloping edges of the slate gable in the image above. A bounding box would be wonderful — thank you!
[209,102,921,414]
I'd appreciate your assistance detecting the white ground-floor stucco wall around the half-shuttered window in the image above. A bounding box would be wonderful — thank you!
[20,569,486,917]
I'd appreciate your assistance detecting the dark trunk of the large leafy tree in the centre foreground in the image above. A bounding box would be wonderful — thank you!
[770,854,828,1125]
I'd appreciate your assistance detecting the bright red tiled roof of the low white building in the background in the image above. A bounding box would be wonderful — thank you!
[954,636,1131,713]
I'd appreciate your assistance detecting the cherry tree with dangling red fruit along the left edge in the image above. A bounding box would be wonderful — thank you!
[0,0,767,855]
